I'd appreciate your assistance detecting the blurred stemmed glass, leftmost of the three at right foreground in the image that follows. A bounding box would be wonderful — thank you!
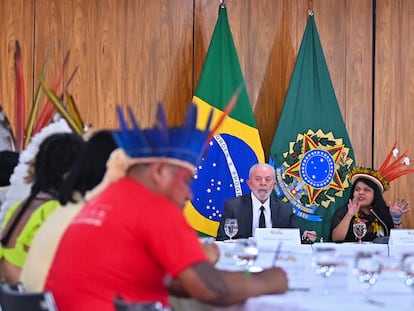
[312,247,340,294]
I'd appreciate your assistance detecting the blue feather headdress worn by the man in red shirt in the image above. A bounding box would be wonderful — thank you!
[114,104,217,170]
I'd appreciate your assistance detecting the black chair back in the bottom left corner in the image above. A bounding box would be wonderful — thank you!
[0,284,58,311]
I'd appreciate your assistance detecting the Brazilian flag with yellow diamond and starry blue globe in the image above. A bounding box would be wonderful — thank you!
[184,5,264,237]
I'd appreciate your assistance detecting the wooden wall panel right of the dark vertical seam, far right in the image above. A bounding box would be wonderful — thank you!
[374,0,414,228]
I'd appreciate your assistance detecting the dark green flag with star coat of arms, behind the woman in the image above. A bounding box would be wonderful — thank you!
[269,12,354,239]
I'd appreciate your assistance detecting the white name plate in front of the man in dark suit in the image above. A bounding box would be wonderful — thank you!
[255,228,301,246]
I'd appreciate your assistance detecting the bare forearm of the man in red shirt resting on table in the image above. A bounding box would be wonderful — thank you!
[169,262,288,306]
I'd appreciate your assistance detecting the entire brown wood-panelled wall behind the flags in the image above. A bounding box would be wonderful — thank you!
[0,0,414,227]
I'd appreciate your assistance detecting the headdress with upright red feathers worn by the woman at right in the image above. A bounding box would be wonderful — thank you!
[349,143,414,192]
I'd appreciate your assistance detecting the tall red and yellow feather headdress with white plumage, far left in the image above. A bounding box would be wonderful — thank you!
[0,41,85,227]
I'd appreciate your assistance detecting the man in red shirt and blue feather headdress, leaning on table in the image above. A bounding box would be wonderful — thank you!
[45,106,287,311]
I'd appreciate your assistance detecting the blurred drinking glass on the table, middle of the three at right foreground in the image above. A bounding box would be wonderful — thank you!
[354,252,382,289]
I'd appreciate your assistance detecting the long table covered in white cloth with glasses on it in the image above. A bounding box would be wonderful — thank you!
[171,242,414,311]
